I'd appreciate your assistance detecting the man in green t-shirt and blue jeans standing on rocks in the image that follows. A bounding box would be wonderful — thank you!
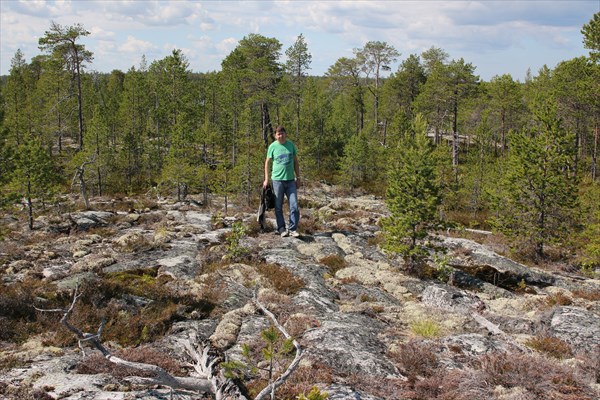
[263,126,300,237]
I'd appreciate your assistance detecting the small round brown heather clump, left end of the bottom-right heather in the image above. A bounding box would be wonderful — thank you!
[389,340,439,382]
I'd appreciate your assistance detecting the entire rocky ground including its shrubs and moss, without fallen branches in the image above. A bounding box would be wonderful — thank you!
[0,187,600,400]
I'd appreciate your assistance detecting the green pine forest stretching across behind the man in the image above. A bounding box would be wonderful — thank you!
[0,13,600,270]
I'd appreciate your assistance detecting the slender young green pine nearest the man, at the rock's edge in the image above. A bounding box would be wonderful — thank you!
[383,117,441,258]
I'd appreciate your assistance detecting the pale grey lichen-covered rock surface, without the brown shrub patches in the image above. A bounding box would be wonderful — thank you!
[0,188,600,400]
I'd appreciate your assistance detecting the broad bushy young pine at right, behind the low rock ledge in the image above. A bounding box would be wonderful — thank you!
[494,106,578,257]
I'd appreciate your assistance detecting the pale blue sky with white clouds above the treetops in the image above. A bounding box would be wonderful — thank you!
[0,0,600,81]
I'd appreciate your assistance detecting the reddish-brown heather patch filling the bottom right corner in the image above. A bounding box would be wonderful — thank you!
[353,342,600,400]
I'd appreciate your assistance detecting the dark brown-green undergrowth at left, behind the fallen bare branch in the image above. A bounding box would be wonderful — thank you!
[0,269,215,346]
